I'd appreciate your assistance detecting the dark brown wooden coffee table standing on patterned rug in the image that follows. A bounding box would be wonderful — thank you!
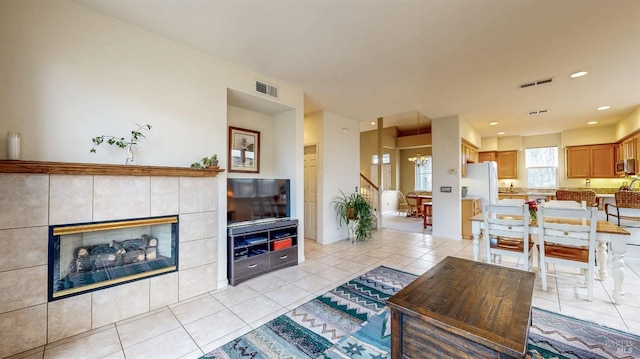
[387,257,535,358]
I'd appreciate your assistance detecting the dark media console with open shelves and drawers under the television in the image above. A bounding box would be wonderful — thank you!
[227,219,298,285]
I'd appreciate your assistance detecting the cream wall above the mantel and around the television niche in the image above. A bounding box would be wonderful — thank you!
[0,0,304,285]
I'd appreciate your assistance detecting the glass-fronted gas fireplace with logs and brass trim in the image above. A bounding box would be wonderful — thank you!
[49,215,179,301]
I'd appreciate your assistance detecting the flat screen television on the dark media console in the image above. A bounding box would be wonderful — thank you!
[227,178,291,224]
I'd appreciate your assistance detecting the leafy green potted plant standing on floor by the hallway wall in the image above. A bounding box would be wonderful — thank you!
[331,187,376,241]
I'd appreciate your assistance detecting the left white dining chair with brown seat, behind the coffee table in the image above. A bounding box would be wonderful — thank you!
[482,204,533,271]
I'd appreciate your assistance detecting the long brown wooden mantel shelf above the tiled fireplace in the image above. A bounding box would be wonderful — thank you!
[0,160,224,177]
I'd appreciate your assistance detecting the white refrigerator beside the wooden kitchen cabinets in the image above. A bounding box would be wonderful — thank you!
[460,161,498,208]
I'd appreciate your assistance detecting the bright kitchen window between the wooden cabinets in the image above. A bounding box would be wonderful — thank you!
[524,146,558,188]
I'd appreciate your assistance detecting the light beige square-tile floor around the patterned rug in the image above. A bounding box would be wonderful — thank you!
[12,229,640,359]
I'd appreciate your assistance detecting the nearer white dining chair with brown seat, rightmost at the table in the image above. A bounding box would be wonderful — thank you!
[538,206,598,301]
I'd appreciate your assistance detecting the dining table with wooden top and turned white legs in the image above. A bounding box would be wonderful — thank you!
[471,213,631,304]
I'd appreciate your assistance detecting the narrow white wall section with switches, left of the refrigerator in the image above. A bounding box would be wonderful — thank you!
[431,116,462,239]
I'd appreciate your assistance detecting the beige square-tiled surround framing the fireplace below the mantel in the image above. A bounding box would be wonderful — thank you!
[0,167,218,358]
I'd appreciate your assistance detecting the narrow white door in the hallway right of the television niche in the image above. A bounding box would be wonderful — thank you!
[304,145,318,240]
